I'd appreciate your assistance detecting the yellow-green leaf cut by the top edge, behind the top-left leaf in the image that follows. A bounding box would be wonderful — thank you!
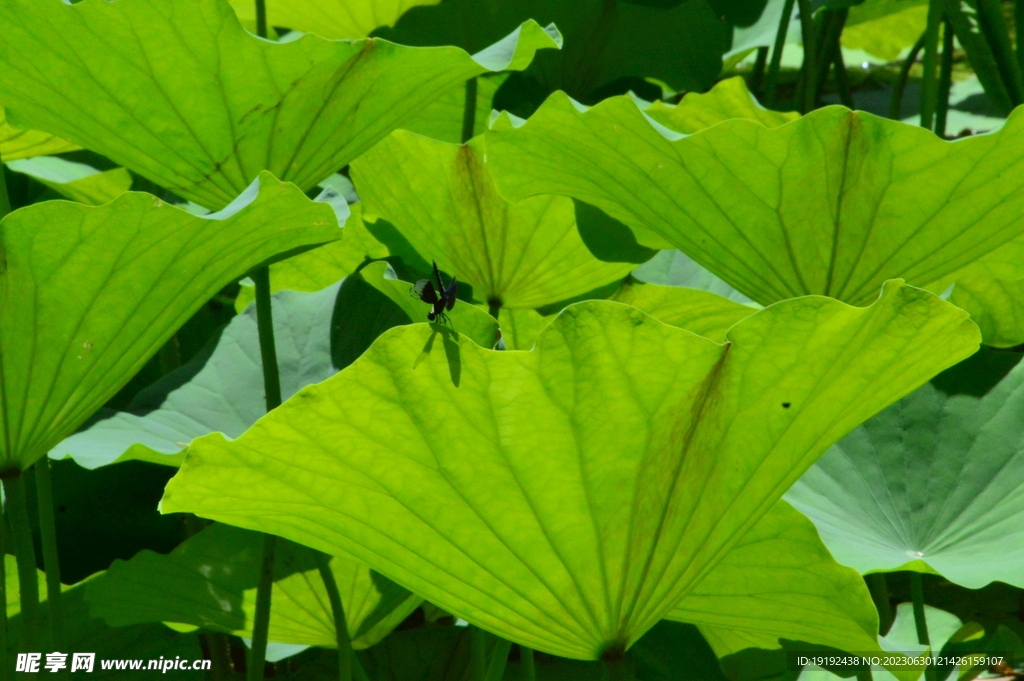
[231,0,440,40]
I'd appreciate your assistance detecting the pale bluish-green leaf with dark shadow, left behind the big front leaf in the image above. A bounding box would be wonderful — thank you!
[50,263,497,468]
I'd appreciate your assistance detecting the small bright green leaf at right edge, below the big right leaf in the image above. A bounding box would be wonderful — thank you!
[949,276,1024,347]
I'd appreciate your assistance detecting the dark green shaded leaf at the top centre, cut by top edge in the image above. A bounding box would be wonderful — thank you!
[378,0,731,101]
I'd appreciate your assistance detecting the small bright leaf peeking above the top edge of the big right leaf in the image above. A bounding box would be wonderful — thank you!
[643,76,800,135]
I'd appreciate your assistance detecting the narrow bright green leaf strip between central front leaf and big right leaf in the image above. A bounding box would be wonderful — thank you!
[609,281,759,343]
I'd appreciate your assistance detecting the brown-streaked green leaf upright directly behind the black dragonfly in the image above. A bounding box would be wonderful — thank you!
[351,130,635,308]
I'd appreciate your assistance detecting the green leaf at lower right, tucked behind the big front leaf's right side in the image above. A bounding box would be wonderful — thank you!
[669,501,882,657]
